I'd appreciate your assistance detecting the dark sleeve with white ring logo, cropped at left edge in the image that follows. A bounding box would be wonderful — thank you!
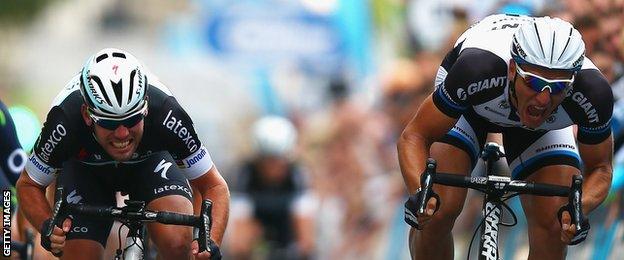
[0,98,26,189]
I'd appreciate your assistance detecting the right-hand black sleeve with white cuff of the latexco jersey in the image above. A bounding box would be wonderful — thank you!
[158,97,213,180]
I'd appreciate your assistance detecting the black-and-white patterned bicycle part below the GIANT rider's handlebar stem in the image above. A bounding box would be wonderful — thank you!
[479,195,502,260]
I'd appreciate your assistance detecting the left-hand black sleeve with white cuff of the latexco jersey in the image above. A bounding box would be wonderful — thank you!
[26,106,72,186]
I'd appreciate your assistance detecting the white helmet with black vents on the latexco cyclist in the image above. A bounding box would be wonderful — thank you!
[80,48,148,119]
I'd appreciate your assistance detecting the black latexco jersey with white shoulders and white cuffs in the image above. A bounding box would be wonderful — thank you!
[26,74,212,185]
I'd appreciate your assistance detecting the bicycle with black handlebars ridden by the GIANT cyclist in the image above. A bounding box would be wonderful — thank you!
[417,143,583,260]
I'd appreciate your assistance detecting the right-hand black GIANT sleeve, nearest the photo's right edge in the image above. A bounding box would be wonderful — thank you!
[568,69,613,144]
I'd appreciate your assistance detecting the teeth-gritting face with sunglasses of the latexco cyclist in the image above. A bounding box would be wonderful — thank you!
[83,104,144,162]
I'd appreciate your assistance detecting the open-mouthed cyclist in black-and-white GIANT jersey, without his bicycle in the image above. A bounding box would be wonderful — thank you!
[398,15,613,259]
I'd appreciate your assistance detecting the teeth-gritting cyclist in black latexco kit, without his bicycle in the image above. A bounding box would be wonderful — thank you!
[17,48,229,259]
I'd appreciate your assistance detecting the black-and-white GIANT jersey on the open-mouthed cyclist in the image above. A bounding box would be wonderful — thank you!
[433,15,613,144]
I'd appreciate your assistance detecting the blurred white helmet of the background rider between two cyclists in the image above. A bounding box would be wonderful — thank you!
[252,116,297,156]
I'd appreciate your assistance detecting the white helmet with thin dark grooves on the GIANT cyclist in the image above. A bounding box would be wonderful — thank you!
[511,16,585,72]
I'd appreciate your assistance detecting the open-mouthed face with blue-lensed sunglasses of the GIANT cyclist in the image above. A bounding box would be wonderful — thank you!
[509,61,572,128]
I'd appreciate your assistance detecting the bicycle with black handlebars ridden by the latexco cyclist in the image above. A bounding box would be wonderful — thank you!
[47,187,217,260]
